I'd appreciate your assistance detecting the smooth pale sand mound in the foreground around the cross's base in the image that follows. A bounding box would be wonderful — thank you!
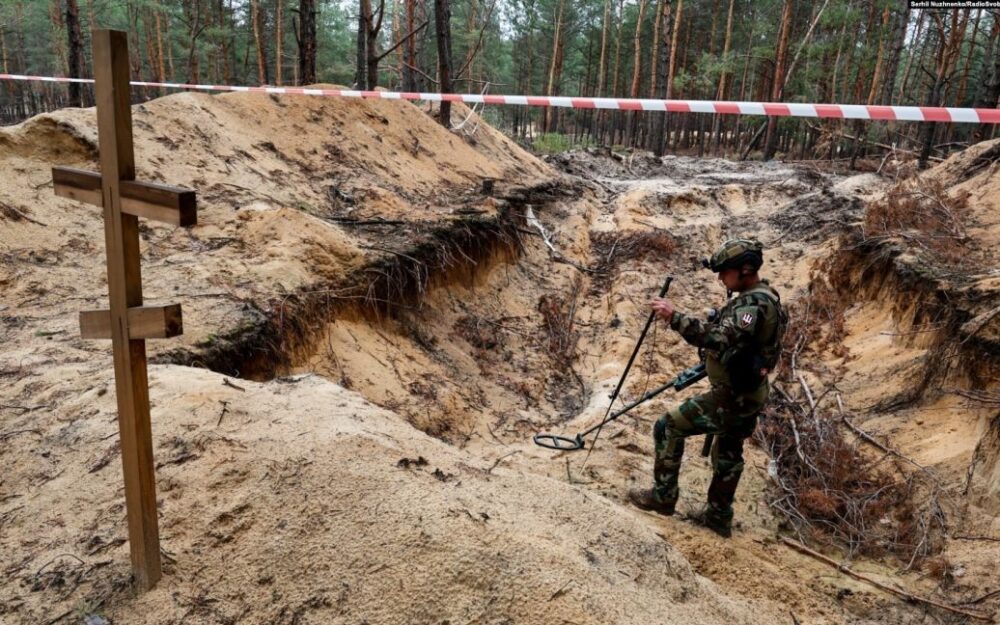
[4,366,792,624]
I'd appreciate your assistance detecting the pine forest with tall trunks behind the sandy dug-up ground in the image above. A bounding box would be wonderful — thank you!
[0,0,1000,166]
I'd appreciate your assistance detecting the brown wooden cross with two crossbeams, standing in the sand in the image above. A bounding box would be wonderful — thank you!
[52,30,197,590]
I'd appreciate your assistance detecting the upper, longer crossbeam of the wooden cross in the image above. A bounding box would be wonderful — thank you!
[52,167,198,227]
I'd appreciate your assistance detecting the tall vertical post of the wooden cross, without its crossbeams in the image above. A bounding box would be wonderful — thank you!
[93,30,161,590]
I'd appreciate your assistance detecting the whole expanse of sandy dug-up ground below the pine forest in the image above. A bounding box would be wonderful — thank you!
[0,94,1000,625]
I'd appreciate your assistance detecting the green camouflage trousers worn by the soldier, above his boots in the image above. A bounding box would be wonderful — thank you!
[653,384,769,527]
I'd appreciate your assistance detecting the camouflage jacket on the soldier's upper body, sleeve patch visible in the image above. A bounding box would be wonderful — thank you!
[670,280,787,394]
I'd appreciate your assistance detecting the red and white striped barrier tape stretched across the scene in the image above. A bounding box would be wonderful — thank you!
[0,74,1000,124]
